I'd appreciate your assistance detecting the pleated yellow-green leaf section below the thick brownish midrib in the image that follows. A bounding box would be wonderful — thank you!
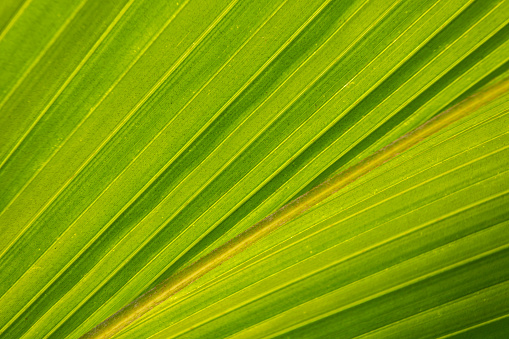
[122,99,509,338]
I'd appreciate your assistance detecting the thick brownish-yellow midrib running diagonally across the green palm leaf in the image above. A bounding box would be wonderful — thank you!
[83,79,509,338]
